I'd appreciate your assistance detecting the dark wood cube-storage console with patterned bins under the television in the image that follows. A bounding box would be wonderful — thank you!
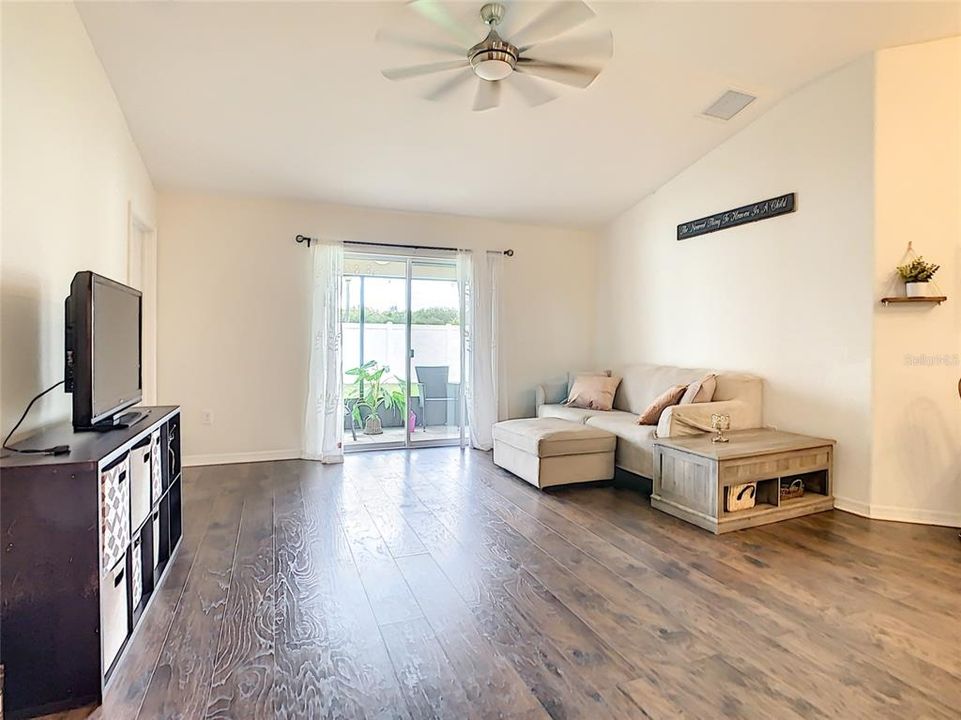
[0,406,183,718]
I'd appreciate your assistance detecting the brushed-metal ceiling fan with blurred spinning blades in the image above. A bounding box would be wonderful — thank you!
[377,0,614,111]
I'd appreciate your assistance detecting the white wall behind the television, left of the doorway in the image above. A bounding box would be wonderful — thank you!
[0,3,154,434]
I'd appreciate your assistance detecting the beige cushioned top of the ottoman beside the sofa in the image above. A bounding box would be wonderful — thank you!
[494,418,616,458]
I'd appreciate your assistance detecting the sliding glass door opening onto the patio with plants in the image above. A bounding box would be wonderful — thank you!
[343,252,465,450]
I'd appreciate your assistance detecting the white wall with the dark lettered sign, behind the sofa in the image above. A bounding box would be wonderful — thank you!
[596,58,874,506]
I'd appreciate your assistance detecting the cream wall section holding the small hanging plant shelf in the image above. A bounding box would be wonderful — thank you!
[868,38,961,525]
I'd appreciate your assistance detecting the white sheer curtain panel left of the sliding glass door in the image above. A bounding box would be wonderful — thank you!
[304,240,344,463]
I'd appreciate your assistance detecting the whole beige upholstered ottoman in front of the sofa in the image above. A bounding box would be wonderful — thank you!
[494,418,617,488]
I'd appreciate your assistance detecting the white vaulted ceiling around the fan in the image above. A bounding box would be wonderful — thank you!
[79,2,961,226]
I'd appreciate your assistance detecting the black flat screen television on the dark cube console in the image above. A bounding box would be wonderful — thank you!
[64,270,143,430]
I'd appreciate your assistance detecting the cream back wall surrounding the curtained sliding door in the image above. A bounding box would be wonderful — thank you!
[158,193,596,462]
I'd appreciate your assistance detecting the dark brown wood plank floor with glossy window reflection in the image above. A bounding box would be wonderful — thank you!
[50,449,961,720]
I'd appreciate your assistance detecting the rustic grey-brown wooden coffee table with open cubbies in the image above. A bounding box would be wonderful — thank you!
[651,429,834,534]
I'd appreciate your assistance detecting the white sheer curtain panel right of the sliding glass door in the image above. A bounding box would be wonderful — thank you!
[457,251,503,450]
